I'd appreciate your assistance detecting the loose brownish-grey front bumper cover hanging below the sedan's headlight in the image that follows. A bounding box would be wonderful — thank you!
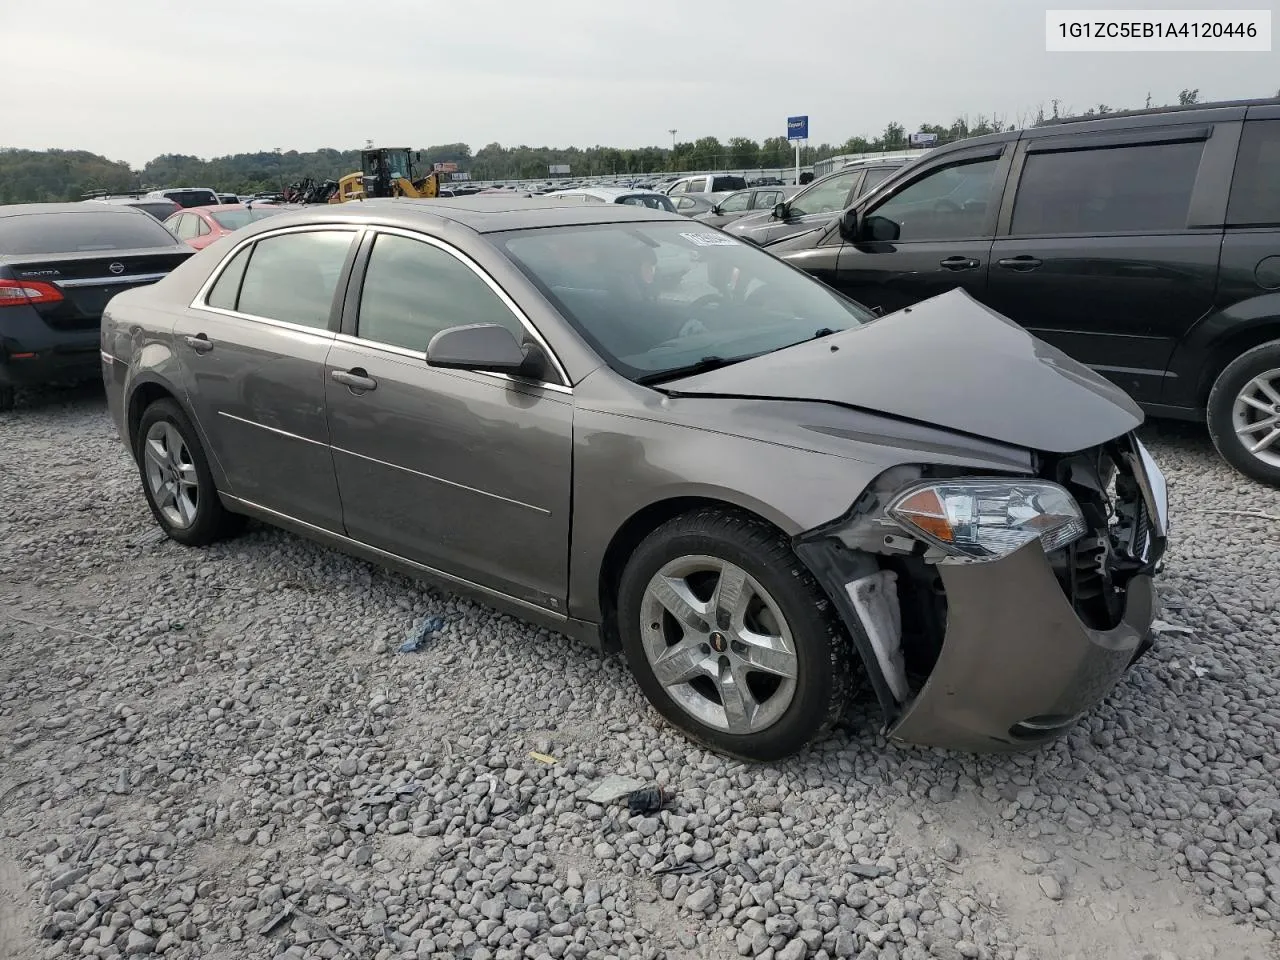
[888,543,1157,751]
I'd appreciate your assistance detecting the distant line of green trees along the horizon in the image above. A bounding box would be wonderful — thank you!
[0,88,1259,204]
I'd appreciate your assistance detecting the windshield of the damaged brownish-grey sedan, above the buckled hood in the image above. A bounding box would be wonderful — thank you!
[499,221,873,381]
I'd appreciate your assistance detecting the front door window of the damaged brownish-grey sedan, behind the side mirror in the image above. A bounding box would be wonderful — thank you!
[360,234,525,352]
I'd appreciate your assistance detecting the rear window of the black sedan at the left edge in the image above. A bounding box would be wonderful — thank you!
[0,209,178,253]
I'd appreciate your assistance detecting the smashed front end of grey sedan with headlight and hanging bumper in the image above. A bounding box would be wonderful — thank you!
[796,434,1167,751]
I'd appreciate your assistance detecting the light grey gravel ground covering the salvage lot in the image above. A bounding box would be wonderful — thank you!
[0,389,1280,960]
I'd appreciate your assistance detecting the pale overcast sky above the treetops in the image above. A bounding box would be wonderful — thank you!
[0,0,1280,166]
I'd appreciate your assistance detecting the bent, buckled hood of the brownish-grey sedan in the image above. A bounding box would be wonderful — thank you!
[659,289,1143,453]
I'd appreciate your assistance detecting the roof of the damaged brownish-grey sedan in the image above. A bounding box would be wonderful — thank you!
[245,196,685,233]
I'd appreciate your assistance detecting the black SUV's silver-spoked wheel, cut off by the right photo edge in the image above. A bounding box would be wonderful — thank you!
[1208,340,1280,486]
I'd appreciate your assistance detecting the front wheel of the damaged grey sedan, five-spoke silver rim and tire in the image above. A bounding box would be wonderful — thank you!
[618,508,854,762]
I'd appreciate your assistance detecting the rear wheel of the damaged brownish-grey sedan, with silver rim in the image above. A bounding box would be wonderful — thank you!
[133,399,243,547]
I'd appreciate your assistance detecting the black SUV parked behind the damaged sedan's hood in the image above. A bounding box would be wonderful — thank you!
[768,100,1280,485]
